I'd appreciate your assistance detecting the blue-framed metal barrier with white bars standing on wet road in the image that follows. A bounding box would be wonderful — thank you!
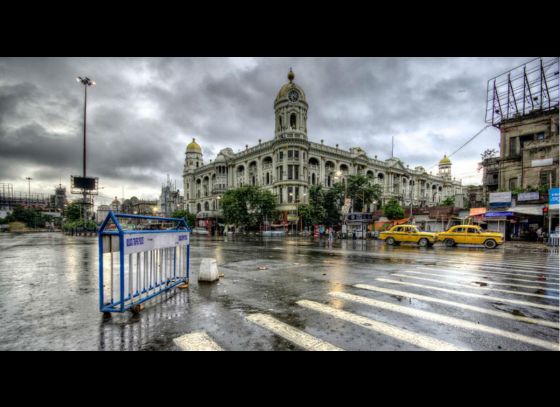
[99,211,191,312]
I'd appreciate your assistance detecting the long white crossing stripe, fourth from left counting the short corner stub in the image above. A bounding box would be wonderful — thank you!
[329,291,559,350]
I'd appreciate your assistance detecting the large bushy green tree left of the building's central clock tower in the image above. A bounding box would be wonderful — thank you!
[222,185,276,229]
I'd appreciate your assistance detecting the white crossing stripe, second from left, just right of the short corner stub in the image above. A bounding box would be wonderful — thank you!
[247,314,344,351]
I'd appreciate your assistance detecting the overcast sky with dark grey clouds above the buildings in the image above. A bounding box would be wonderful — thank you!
[0,57,531,203]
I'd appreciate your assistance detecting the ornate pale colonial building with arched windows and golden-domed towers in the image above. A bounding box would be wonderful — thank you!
[183,70,462,223]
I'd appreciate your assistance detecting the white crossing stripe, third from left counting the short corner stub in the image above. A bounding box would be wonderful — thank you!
[297,300,468,351]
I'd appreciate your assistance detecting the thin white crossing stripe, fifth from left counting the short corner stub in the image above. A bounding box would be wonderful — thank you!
[354,284,560,329]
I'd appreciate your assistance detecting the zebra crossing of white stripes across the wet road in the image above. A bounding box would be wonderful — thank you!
[175,253,560,351]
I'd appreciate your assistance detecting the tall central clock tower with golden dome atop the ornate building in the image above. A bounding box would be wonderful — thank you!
[274,68,308,140]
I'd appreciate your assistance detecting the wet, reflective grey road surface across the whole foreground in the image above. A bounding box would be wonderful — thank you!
[0,233,559,350]
